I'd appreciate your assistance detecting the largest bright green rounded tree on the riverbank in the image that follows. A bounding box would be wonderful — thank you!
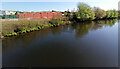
[76,3,95,21]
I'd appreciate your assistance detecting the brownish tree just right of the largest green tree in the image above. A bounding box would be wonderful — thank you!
[94,7,106,19]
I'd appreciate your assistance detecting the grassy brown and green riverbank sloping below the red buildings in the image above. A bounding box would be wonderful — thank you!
[0,18,70,38]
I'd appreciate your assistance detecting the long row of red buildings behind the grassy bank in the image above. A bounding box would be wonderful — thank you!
[19,12,62,19]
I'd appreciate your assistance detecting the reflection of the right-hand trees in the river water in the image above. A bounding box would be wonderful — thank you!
[70,19,116,37]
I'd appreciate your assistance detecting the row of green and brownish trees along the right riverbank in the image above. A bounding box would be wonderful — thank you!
[64,3,119,21]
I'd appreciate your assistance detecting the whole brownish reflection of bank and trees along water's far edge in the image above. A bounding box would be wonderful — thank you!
[2,19,116,52]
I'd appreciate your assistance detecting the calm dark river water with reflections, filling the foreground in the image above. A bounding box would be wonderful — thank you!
[2,20,119,67]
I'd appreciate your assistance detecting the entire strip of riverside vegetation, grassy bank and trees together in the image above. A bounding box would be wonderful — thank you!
[0,3,119,38]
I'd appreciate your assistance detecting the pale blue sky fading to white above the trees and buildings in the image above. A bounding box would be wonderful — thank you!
[1,0,119,12]
